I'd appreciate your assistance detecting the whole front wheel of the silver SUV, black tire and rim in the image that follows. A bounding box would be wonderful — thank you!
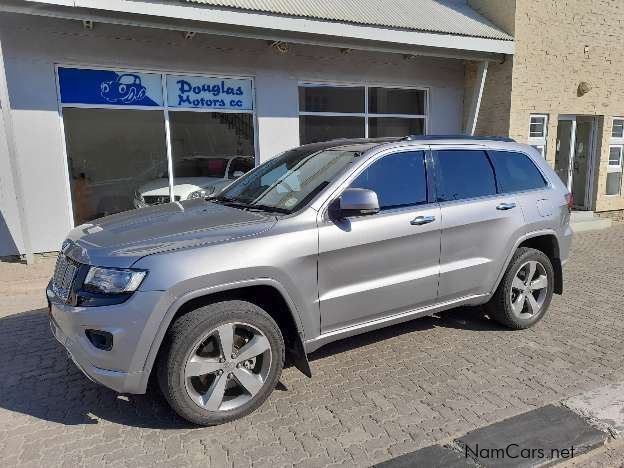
[157,300,285,426]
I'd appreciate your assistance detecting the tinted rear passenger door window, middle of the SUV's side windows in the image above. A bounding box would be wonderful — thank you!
[436,150,496,202]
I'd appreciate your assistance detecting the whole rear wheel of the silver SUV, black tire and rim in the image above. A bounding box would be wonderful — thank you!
[485,247,555,330]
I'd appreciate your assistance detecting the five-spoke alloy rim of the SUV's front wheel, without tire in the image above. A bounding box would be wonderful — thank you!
[184,323,272,411]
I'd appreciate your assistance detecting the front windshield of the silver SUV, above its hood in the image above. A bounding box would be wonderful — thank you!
[216,146,361,213]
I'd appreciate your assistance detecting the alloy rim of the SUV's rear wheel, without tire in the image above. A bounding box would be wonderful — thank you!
[510,260,548,319]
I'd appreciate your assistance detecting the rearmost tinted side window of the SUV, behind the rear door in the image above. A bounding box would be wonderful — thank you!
[488,151,546,193]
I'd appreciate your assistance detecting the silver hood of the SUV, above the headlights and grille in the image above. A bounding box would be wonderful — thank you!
[63,200,277,268]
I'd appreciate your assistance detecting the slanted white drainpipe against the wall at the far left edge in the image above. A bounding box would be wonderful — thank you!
[0,31,35,265]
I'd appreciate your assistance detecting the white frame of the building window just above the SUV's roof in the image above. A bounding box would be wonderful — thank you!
[297,81,431,145]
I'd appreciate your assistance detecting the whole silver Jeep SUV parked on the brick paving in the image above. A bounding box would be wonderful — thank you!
[47,137,572,425]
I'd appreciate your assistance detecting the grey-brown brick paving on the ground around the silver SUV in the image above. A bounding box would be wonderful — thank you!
[0,224,624,468]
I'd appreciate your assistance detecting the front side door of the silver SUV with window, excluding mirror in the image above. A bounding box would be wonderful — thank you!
[318,151,440,333]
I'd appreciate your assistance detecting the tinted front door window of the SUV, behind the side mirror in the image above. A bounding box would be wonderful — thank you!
[350,151,427,210]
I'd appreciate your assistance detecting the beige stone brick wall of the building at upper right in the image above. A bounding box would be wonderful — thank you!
[466,0,624,211]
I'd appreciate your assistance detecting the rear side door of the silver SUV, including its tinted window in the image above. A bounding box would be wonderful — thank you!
[433,148,525,301]
